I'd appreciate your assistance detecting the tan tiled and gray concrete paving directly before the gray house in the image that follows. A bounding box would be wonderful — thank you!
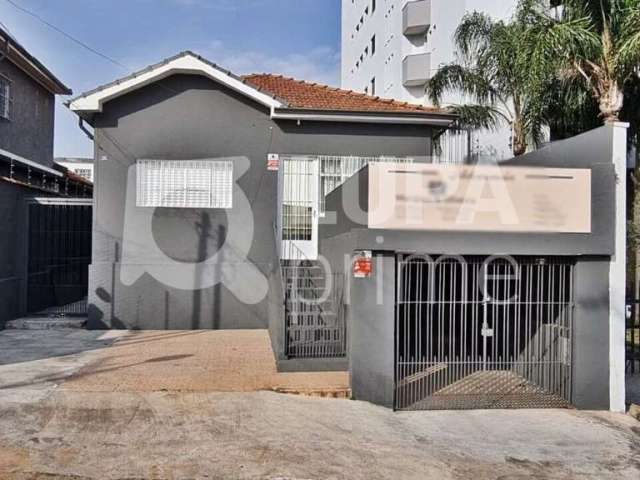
[0,330,349,393]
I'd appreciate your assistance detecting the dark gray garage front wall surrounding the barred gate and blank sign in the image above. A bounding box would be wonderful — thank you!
[320,126,619,409]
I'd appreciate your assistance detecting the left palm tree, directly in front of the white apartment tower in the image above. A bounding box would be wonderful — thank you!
[426,12,551,155]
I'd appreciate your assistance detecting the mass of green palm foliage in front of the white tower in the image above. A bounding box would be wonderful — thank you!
[426,0,640,154]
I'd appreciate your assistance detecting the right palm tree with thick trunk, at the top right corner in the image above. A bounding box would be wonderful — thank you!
[520,0,640,122]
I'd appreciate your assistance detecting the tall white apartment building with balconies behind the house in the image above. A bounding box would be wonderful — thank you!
[342,0,517,160]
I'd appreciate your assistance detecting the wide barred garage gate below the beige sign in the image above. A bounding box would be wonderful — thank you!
[394,255,573,410]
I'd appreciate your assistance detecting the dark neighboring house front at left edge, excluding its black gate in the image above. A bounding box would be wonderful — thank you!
[0,29,71,329]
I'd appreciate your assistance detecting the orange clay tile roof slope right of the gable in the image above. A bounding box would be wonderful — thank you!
[242,73,451,114]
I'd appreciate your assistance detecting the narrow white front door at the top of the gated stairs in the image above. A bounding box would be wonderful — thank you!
[281,156,319,260]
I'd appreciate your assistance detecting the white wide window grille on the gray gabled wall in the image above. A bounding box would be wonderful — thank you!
[136,160,233,208]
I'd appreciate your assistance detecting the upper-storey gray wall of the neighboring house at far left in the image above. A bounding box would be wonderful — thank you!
[0,59,55,166]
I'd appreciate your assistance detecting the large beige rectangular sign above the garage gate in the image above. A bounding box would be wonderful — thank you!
[368,163,591,233]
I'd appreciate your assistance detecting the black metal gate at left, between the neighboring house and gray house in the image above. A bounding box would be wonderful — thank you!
[26,198,92,316]
